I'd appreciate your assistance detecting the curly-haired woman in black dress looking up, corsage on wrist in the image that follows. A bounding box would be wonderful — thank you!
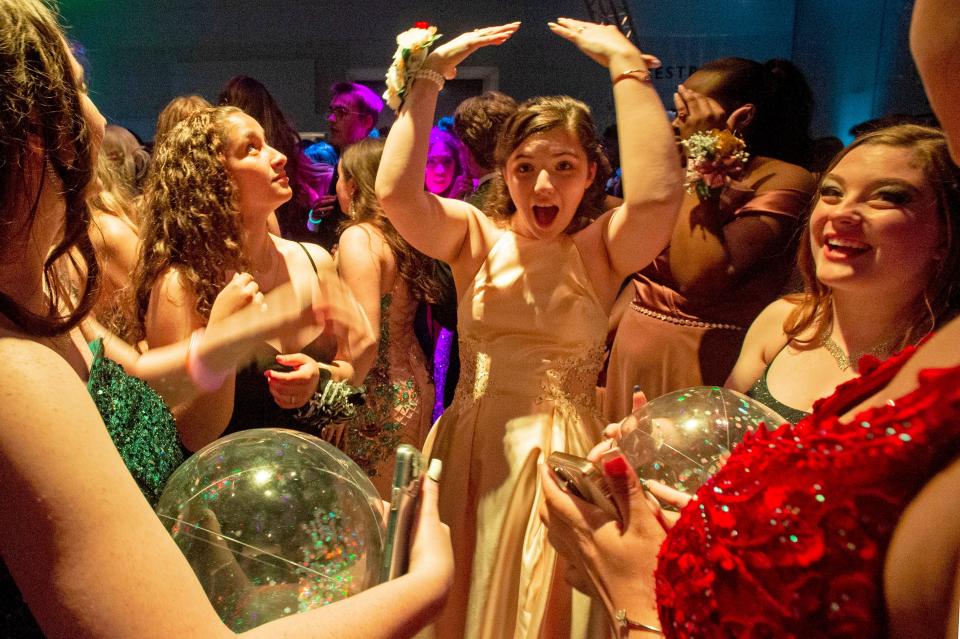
[134,107,375,450]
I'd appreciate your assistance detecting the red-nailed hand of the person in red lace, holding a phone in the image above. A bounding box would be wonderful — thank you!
[540,455,666,625]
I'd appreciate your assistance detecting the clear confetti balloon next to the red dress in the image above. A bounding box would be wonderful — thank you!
[620,386,787,493]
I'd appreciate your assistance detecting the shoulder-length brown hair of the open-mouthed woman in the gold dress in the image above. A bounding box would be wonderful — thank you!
[485,95,610,233]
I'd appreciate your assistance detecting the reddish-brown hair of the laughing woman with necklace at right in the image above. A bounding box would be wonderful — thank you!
[783,124,960,349]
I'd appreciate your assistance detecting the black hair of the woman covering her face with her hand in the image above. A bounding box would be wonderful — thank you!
[697,57,814,166]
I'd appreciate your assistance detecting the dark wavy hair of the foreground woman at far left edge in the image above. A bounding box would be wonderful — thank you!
[0,0,100,336]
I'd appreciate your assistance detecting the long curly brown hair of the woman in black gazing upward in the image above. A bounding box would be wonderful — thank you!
[133,107,249,339]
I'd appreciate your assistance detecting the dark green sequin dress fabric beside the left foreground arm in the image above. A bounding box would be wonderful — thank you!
[87,339,183,505]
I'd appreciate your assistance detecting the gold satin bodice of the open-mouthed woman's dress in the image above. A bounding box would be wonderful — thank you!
[454,231,607,422]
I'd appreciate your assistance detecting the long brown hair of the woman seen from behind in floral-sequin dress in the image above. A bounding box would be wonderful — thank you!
[340,138,443,304]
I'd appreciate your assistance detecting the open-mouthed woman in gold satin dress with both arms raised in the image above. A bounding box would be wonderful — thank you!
[376,18,682,638]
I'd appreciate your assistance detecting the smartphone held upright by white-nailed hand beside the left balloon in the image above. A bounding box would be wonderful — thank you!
[380,444,423,582]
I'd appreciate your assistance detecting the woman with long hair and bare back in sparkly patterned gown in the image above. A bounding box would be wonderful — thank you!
[337,138,441,498]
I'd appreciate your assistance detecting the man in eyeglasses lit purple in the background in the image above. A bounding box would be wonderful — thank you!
[304,82,383,251]
